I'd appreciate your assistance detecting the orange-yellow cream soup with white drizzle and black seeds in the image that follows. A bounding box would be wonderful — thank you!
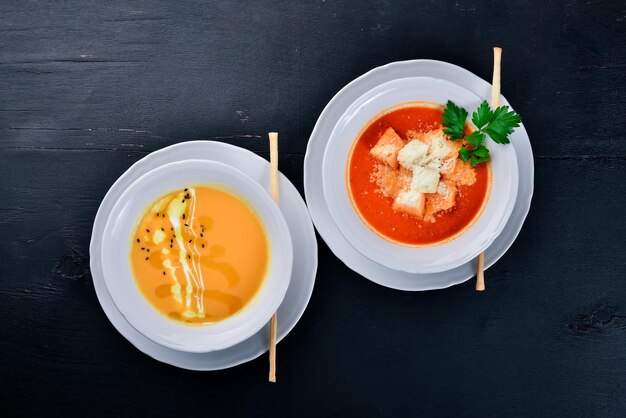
[130,186,270,324]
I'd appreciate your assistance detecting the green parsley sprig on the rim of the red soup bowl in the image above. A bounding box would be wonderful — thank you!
[441,100,522,167]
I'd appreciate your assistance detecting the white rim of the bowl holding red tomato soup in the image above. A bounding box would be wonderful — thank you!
[322,77,519,274]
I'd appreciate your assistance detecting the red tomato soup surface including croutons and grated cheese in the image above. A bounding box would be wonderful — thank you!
[346,104,491,246]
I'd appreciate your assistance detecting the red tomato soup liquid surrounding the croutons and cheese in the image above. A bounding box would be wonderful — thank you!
[346,103,491,246]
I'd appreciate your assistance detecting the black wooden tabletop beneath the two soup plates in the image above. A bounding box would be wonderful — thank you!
[0,0,626,417]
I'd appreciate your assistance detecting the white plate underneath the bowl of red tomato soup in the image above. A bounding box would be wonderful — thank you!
[304,60,534,291]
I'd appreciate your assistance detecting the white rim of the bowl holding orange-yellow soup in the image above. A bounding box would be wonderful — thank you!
[101,160,293,353]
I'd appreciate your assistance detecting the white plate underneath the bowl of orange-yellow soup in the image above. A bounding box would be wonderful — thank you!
[89,141,317,370]
